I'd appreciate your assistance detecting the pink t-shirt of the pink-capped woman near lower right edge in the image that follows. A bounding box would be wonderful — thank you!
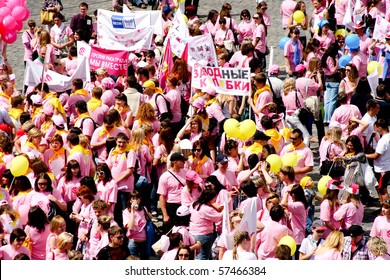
[333,202,364,230]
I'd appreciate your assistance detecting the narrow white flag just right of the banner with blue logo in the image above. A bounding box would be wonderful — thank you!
[165,10,190,57]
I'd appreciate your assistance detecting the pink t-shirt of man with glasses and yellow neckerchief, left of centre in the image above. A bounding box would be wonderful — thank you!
[106,150,137,192]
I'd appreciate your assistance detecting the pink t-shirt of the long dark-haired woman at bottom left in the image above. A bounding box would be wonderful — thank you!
[24,224,50,260]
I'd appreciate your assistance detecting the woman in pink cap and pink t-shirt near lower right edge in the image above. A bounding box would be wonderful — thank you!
[333,184,364,231]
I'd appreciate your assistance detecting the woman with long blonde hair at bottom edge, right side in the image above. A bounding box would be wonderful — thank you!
[314,230,344,260]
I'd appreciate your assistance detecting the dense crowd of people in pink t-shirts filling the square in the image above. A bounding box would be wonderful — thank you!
[0,0,390,260]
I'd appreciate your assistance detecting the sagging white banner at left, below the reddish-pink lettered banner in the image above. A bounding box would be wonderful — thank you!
[24,58,91,92]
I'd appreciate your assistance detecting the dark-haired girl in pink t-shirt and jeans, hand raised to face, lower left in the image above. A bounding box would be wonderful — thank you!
[123,191,149,260]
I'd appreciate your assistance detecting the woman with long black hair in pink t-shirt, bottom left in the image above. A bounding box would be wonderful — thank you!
[24,206,50,260]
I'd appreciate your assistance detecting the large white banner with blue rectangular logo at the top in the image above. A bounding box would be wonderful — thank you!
[97,9,154,51]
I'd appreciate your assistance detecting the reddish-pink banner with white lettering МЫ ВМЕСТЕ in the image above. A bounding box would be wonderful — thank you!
[89,46,128,76]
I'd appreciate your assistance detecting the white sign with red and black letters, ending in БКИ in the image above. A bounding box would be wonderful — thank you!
[191,63,251,96]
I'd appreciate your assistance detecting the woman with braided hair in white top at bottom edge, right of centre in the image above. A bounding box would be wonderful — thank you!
[222,231,257,261]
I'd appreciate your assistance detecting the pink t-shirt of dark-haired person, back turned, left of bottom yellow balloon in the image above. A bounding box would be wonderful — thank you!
[256,220,291,260]
